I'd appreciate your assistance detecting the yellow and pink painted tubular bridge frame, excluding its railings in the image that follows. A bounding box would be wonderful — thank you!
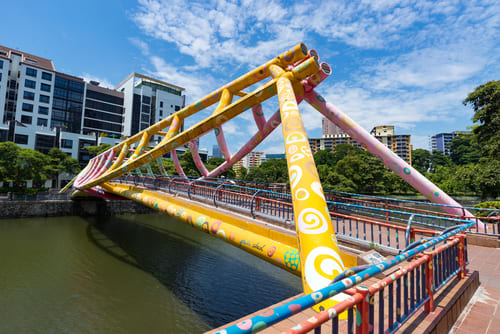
[63,44,482,332]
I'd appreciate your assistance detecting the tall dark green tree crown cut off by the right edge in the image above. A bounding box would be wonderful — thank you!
[463,80,500,160]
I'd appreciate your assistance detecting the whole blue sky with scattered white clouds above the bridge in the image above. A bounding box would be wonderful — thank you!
[0,0,500,152]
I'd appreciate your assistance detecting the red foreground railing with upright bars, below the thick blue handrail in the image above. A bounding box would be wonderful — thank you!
[285,235,466,334]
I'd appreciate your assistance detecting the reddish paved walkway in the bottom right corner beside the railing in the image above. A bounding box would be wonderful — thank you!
[450,245,500,334]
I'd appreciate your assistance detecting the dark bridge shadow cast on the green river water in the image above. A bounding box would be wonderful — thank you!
[87,215,301,328]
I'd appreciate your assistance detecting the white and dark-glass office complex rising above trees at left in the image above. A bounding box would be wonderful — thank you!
[0,46,187,164]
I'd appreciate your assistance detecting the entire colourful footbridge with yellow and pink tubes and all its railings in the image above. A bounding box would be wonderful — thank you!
[63,44,498,333]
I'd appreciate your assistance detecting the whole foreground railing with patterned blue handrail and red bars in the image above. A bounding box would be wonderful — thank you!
[217,223,472,334]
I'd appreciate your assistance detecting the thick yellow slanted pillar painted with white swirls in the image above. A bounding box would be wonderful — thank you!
[270,65,345,309]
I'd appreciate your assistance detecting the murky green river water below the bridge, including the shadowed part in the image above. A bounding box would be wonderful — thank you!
[0,214,301,334]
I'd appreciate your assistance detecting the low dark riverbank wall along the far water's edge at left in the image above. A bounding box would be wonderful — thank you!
[0,199,156,219]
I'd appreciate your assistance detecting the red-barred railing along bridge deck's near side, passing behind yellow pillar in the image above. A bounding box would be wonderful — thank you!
[113,176,437,254]
